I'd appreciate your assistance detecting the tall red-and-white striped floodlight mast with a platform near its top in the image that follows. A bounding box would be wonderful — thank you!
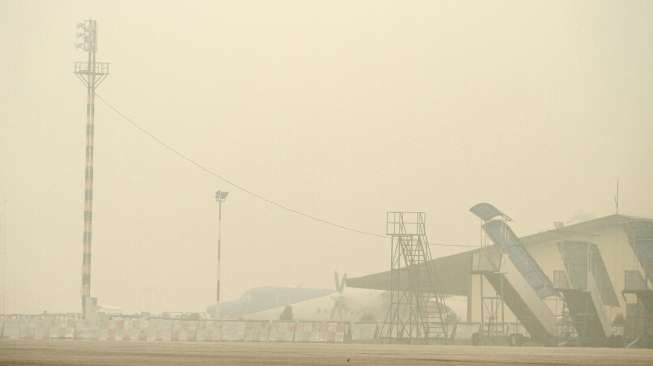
[74,19,109,318]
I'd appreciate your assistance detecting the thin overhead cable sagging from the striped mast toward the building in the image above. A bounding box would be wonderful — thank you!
[95,93,474,248]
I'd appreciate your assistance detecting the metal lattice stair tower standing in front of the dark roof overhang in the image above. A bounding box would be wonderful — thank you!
[379,212,448,343]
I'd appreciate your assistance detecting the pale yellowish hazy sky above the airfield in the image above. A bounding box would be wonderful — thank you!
[0,0,653,312]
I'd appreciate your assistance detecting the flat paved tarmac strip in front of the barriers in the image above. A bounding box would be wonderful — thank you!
[0,340,653,366]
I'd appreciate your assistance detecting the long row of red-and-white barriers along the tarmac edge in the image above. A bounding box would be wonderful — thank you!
[0,315,366,343]
